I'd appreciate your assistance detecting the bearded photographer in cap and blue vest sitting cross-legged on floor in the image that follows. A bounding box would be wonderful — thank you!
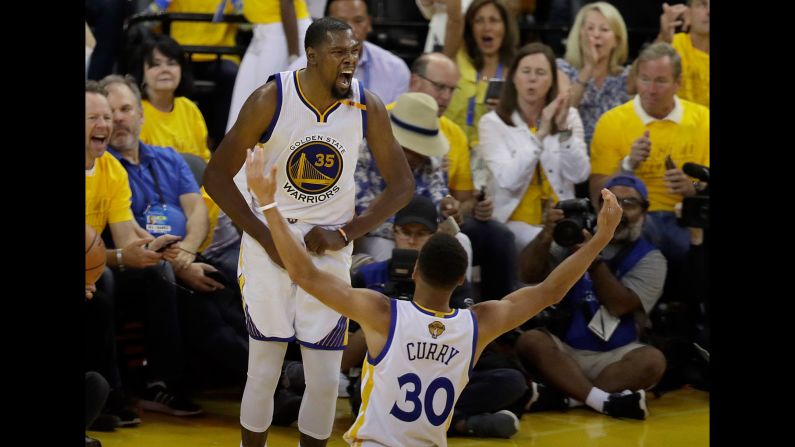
[516,174,667,419]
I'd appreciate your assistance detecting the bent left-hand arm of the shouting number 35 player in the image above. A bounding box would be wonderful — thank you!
[204,81,282,265]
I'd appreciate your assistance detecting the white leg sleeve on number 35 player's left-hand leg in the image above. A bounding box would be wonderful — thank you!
[240,338,287,433]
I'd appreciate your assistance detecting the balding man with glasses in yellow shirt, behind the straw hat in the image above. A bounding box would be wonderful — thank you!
[409,53,517,299]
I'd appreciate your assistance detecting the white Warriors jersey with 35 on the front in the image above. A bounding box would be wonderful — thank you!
[235,70,367,226]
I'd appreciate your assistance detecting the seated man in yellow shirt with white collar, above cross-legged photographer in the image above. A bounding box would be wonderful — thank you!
[589,42,709,262]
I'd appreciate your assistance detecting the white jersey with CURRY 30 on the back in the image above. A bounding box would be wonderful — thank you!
[344,300,478,447]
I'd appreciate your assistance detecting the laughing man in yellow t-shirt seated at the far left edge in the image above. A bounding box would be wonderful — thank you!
[86,81,203,425]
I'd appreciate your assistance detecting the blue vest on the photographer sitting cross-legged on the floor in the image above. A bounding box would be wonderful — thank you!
[562,239,655,352]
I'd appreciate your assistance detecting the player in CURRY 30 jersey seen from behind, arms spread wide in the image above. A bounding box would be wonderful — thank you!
[246,148,622,447]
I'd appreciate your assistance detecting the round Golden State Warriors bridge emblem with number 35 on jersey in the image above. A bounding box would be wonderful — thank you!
[282,135,345,203]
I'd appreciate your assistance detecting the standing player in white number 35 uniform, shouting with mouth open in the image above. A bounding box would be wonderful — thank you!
[204,18,414,447]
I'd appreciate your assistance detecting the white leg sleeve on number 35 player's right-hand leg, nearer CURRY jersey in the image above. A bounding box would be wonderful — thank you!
[298,346,342,439]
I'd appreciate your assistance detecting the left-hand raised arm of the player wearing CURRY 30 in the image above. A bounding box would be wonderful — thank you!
[246,148,391,335]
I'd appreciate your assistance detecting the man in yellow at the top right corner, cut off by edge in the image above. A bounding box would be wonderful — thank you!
[657,0,709,107]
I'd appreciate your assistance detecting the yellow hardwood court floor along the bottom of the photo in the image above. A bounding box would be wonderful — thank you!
[89,388,709,447]
